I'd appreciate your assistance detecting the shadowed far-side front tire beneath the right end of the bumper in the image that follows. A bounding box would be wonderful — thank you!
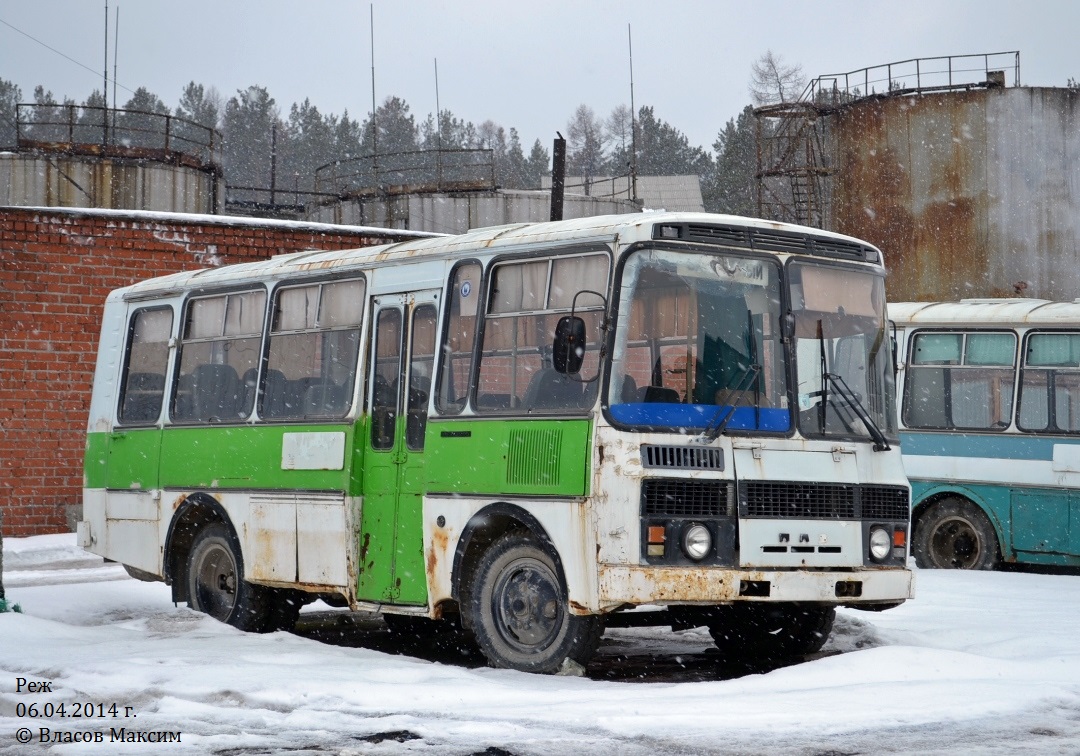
[708,602,836,662]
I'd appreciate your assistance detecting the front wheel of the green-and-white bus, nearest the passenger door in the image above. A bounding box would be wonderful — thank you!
[467,532,603,674]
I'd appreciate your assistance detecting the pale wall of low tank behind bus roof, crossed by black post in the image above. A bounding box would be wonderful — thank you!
[307,190,639,233]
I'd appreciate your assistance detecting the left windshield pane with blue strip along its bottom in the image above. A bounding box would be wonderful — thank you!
[608,249,791,432]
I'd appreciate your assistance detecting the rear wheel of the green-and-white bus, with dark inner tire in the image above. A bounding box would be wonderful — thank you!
[188,523,273,633]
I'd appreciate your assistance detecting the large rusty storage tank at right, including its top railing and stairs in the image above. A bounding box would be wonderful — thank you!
[758,53,1080,300]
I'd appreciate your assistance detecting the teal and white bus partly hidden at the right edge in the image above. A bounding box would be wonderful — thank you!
[889,299,1080,569]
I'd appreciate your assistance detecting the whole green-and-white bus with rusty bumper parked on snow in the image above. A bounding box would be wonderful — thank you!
[79,213,913,672]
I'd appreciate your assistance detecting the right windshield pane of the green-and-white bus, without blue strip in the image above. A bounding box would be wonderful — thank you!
[788,262,896,443]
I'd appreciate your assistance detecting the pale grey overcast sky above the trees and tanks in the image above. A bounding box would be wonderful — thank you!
[0,0,1080,151]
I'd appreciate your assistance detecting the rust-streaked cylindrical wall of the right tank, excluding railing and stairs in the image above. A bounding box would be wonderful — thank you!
[831,87,1080,300]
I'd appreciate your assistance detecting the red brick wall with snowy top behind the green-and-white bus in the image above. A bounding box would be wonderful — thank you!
[0,207,421,536]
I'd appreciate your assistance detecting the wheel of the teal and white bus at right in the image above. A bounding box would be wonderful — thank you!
[912,498,1001,569]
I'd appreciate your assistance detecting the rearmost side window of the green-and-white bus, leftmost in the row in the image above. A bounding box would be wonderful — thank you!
[119,308,173,424]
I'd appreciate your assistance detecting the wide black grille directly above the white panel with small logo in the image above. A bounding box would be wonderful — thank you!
[740,481,909,521]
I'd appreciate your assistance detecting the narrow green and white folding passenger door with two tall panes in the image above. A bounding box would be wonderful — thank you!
[357,291,438,605]
